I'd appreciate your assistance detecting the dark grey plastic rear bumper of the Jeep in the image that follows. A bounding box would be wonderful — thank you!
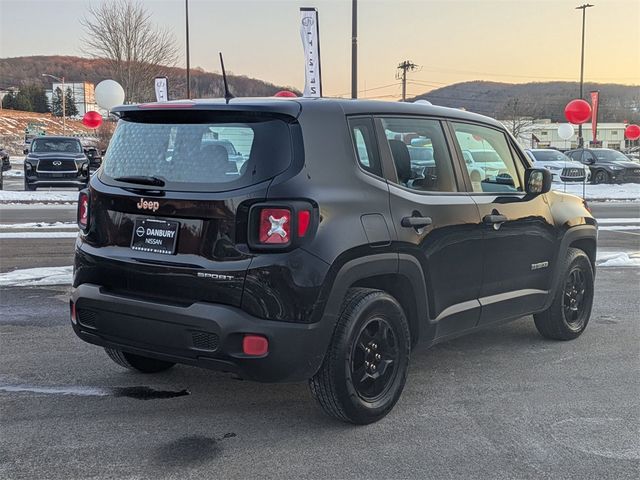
[71,284,335,382]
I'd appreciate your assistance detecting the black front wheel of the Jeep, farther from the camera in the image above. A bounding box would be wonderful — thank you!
[533,248,594,340]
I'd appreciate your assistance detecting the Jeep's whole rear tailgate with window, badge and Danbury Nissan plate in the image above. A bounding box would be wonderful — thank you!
[74,104,302,306]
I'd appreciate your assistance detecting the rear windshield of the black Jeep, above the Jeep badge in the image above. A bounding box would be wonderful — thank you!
[100,113,293,192]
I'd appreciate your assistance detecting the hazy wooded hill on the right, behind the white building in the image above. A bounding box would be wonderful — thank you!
[411,79,640,122]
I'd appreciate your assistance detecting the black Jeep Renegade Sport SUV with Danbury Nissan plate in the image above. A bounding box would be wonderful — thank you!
[71,98,596,423]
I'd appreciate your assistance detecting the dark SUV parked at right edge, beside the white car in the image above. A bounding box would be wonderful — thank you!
[567,148,640,184]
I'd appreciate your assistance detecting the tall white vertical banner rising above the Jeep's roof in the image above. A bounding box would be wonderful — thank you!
[300,8,322,97]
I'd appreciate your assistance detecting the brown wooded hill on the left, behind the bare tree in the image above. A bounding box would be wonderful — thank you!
[0,56,296,100]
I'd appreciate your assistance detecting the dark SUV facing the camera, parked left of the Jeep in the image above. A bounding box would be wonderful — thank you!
[24,136,89,190]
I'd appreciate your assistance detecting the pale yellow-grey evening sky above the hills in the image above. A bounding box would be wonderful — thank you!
[0,0,640,100]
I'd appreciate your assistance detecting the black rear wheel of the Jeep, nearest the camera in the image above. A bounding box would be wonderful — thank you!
[309,288,411,425]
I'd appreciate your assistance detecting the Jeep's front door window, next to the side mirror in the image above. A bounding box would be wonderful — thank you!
[453,123,522,192]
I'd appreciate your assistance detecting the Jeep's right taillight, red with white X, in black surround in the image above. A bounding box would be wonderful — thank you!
[247,200,318,251]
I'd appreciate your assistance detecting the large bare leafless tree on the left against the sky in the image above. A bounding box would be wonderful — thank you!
[81,0,178,102]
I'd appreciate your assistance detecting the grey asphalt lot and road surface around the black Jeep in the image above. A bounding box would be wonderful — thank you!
[0,204,640,479]
